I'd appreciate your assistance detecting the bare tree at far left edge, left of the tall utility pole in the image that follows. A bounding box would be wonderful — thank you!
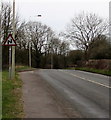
[0,3,12,67]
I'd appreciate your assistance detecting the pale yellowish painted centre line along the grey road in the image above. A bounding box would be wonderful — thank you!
[59,70,111,88]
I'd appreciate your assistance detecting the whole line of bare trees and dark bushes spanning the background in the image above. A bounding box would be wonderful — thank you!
[0,3,111,69]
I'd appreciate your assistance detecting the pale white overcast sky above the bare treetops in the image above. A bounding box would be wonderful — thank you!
[2,0,110,32]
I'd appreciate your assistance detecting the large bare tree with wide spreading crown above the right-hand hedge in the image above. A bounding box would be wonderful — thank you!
[66,13,108,60]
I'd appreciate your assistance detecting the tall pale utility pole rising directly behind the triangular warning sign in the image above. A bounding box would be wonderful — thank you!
[11,0,15,79]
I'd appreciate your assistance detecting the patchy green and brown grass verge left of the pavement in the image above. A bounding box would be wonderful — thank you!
[2,71,23,118]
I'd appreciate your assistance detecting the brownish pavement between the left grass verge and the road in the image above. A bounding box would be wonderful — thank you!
[20,70,79,118]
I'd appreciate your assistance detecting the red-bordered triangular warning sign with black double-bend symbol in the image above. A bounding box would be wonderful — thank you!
[3,34,16,46]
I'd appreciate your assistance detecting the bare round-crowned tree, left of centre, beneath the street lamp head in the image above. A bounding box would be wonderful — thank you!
[25,22,53,67]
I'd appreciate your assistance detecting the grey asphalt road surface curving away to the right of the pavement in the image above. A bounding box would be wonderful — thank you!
[39,69,109,118]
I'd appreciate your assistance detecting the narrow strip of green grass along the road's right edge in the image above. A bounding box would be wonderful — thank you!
[75,68,111,76]
